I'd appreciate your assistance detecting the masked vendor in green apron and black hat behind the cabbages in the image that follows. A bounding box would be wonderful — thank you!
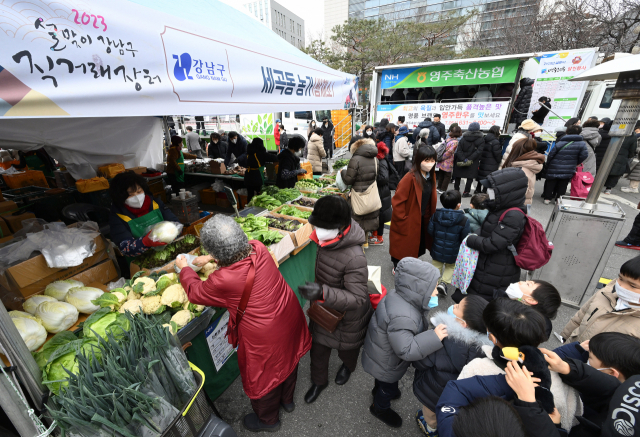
[109,170,179,260]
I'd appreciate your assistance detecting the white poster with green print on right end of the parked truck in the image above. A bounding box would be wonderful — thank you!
[529,49,596,132]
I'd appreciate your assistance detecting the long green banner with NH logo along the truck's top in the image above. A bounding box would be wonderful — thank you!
[382,59,520,89]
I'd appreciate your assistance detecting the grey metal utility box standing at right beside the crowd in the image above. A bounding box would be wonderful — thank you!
[533,197,625,308]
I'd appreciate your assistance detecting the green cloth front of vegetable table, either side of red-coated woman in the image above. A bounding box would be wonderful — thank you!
[186,243,317,401]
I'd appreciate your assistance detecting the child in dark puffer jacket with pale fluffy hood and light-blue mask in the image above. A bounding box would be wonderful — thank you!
[413,296,493,431]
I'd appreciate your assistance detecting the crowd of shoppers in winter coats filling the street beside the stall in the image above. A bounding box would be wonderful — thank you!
[164,110,640,437]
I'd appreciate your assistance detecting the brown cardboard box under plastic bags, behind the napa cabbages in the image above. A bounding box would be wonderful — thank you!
[0,235,113,310]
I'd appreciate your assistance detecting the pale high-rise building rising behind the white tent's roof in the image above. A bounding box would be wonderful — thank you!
[242,0,305,48]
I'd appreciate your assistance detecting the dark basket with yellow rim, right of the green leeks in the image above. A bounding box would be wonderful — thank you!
[162,363,213,437]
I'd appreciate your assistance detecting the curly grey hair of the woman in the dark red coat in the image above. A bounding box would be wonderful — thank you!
[200,214,251,266]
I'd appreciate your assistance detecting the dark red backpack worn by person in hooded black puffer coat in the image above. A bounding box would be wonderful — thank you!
[499,208,553,271]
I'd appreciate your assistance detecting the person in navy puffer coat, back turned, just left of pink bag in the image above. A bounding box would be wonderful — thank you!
[543,125,589,205]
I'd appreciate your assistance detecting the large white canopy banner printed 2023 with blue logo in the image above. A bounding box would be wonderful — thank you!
[0,0,357,118]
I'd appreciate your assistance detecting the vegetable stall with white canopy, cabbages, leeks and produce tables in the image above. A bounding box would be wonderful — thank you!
[0,0,357,437]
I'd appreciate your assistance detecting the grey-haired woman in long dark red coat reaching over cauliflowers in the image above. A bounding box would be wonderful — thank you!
[176,214,311,431]
